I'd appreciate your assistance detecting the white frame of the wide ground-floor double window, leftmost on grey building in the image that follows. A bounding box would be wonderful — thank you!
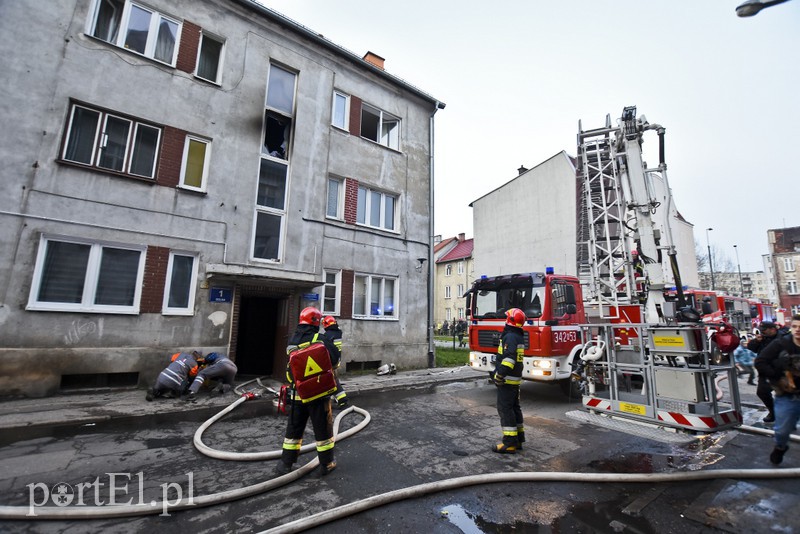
[26,234,147,315]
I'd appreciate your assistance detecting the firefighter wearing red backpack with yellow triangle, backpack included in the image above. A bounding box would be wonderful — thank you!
[275,307,339,475]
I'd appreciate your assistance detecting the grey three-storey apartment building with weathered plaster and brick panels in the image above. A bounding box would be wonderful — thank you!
[0,0,444,396]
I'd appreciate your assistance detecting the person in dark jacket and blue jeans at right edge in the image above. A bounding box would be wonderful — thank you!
[755,314,800,465]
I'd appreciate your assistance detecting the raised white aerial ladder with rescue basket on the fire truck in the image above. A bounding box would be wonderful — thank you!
[575,106,742,432]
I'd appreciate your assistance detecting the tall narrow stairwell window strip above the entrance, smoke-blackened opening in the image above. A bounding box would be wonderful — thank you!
[253,65,297,261]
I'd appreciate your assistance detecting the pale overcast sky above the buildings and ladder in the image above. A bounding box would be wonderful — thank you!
[260,0,800,272]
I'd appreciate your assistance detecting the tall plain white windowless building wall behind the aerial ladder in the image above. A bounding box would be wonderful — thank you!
[470,151,698,287]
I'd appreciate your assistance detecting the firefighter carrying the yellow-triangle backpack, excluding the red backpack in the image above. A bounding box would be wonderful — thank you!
[275,307,339,475]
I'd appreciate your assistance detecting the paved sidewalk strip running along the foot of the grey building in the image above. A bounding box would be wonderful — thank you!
[0,366,485,432]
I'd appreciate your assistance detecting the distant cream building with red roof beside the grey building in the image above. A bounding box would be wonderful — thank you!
[434,234,475,329]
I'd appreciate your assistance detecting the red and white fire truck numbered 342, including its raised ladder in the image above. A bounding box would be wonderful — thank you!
[467,106,750,432]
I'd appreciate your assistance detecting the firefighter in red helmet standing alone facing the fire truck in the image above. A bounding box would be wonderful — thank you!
[492,308,525,454]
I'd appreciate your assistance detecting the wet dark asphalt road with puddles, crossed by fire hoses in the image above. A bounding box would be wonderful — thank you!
[0,380,800,534]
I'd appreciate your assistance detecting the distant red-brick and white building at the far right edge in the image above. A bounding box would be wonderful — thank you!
[765,226,800,314]
